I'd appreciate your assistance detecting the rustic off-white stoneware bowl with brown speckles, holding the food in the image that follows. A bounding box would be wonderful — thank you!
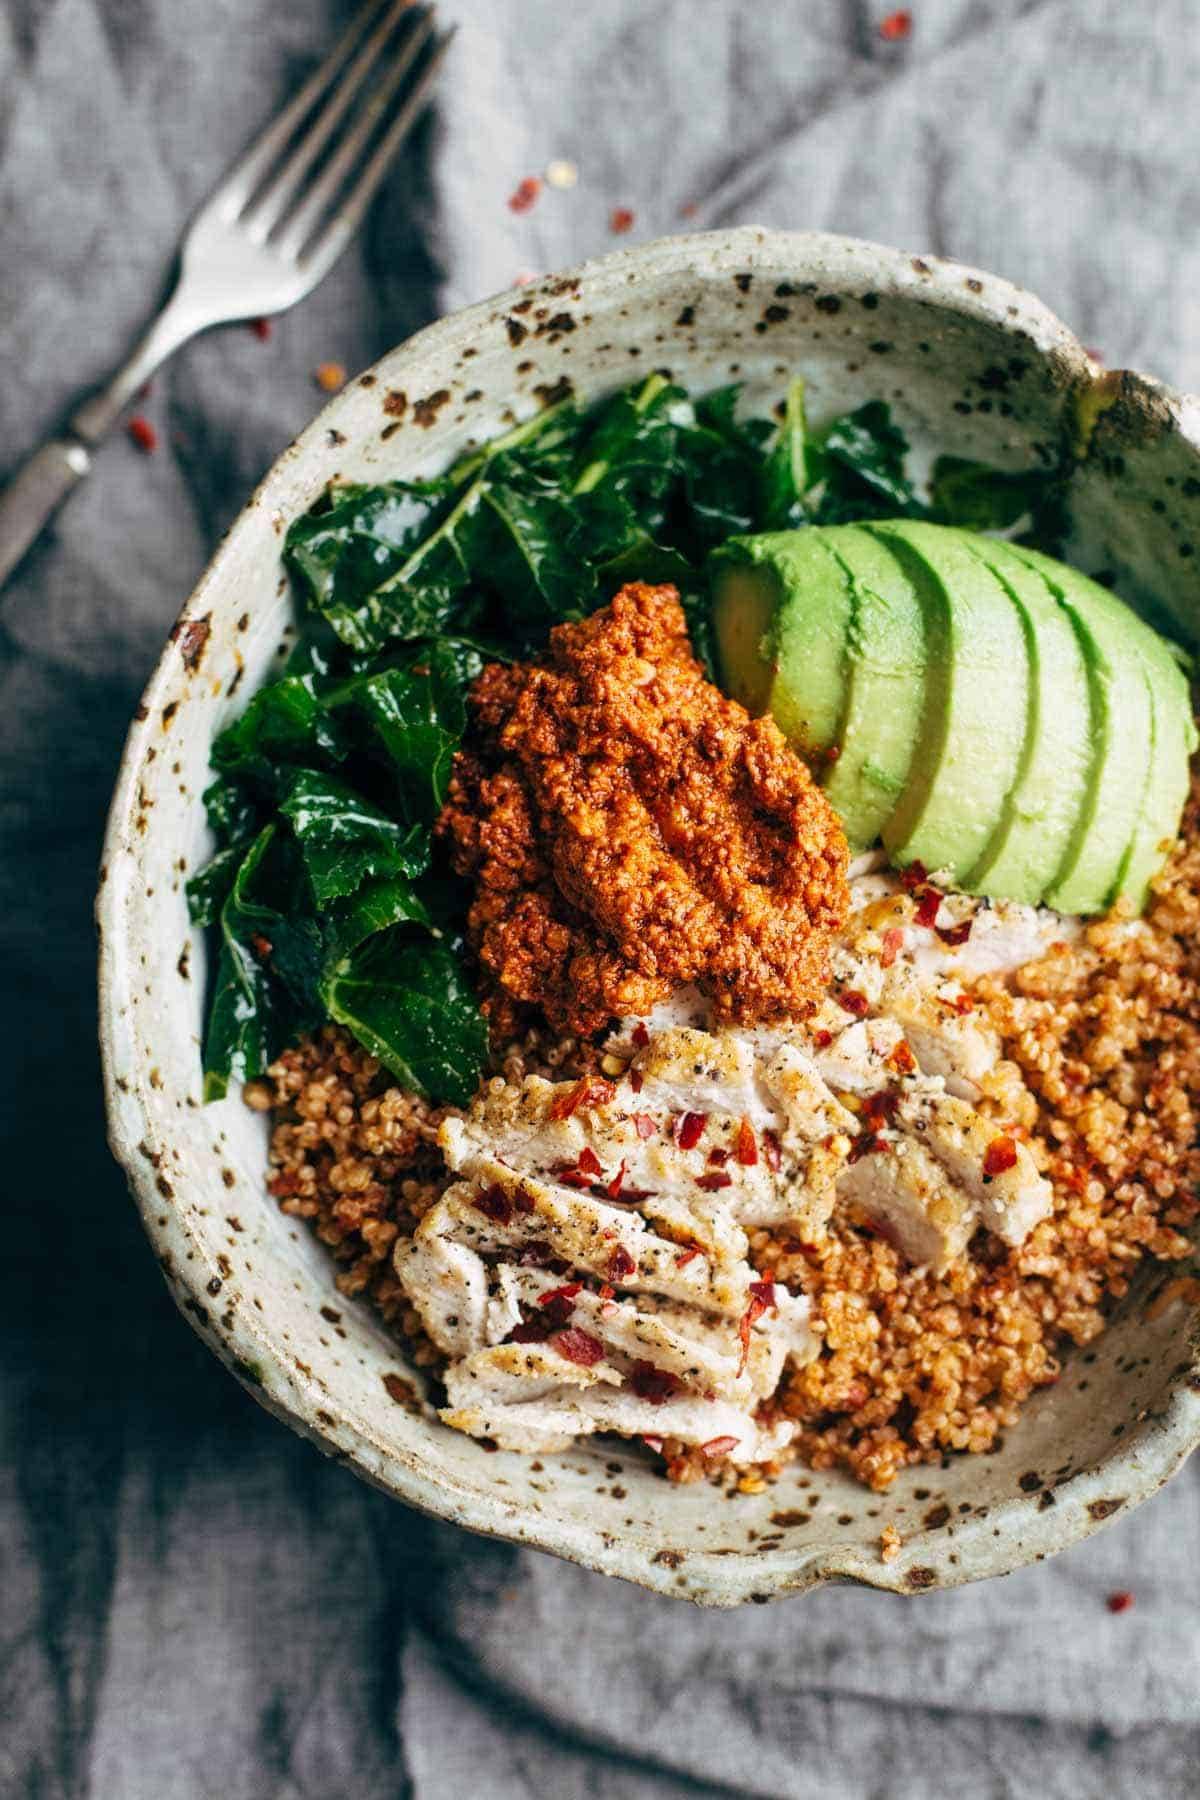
[99,229,1200,1606]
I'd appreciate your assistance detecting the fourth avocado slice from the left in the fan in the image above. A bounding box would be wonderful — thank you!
[963,533,1094,905]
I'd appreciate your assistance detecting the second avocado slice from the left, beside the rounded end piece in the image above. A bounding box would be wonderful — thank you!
[822,526,925,850]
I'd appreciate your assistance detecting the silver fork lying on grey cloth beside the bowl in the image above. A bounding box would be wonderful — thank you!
[0,0,453,583]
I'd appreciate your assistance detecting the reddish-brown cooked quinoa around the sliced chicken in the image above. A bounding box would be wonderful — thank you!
[259,792,1200,1492]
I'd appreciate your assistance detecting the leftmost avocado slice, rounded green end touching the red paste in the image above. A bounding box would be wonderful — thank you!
[712,527,851,756]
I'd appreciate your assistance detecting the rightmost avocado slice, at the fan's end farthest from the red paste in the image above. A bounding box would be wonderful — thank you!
[1013,545,1196,913]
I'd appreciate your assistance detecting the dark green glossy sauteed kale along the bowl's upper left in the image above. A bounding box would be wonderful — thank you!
[187,374,1058,1103]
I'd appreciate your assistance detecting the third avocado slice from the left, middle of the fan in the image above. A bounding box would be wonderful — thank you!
[862,520,1029,882]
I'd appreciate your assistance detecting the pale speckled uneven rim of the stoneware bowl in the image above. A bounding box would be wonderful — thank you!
[97,227,1200,1606]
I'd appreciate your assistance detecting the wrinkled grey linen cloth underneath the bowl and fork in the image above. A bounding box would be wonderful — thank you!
[0,0,1200,1800]
